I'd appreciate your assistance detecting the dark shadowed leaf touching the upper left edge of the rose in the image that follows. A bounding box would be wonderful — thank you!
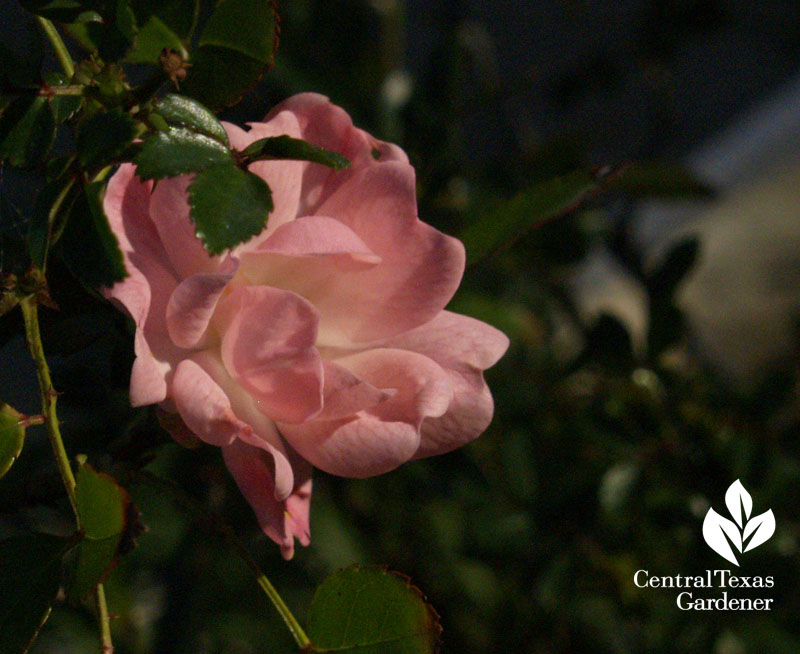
[61,182,128,288]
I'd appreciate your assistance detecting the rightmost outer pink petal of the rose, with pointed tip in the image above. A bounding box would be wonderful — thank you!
[383,311,508,458]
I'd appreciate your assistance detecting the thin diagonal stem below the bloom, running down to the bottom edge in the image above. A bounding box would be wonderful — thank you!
[136,471,312,652]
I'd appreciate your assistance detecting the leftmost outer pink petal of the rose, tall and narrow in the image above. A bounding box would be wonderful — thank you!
[103,164,178,406]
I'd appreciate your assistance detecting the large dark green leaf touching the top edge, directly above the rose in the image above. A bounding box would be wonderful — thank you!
[184,0,277,109]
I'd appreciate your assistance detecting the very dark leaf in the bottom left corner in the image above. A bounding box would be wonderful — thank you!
[0,534,75,654]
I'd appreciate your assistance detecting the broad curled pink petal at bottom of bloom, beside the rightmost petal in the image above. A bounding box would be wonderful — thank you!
[278,349,453,477]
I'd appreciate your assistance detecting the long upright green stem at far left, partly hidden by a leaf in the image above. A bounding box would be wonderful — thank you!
[20,295,114,654]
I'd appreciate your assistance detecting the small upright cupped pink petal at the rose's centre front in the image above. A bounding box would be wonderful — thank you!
[217,286,323,422]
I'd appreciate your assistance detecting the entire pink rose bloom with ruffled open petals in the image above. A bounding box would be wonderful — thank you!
[105,94,508,558]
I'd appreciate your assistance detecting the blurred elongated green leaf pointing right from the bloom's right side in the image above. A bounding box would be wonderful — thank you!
[461,171,598,265]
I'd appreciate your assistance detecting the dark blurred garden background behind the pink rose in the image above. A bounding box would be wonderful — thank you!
[0,0,800,654]
